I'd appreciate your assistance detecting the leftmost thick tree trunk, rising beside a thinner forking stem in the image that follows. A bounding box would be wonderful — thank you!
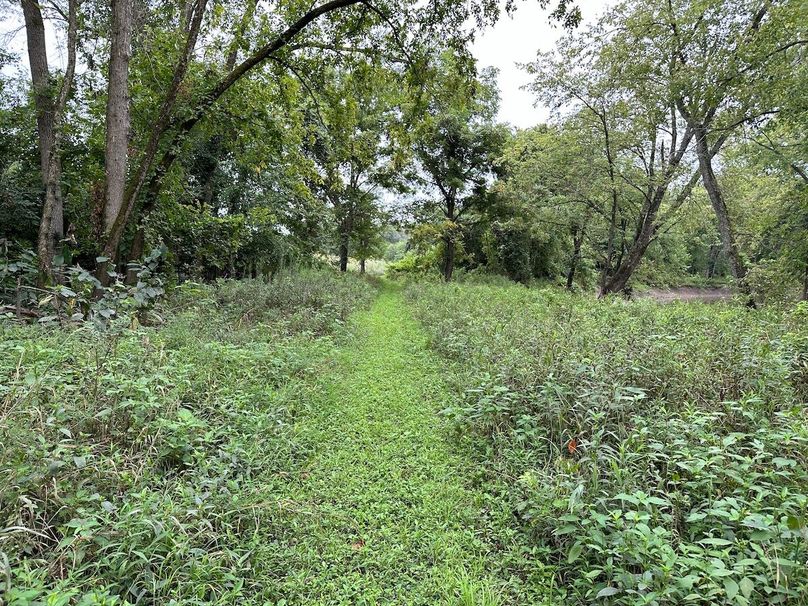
[21,0,64,279]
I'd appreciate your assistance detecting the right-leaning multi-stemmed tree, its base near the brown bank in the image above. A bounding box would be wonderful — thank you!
[529,21,695,294]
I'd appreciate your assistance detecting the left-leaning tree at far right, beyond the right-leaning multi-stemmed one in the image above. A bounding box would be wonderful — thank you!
[664,0,791,279]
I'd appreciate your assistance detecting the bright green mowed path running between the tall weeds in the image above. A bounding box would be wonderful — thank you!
[278,289,508,605]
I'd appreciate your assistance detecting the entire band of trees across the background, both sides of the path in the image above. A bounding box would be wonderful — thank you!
[0,0,808,294]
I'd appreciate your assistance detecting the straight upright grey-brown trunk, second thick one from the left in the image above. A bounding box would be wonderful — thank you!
[99,0,132,282]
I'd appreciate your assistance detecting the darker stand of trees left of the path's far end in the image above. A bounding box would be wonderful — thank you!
[0,0,578,283]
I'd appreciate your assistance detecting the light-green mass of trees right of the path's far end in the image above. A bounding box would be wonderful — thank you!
[400,0,808,297]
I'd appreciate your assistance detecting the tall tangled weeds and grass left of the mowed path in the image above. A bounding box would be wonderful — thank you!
[0,272,373,606]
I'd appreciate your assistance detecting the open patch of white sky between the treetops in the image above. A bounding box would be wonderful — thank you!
[472,0,617,128]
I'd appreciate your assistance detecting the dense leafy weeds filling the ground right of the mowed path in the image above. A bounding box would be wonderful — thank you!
[408,284,808,606]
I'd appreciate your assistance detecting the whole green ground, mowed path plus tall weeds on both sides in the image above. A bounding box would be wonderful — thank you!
[0,272,808,606]
